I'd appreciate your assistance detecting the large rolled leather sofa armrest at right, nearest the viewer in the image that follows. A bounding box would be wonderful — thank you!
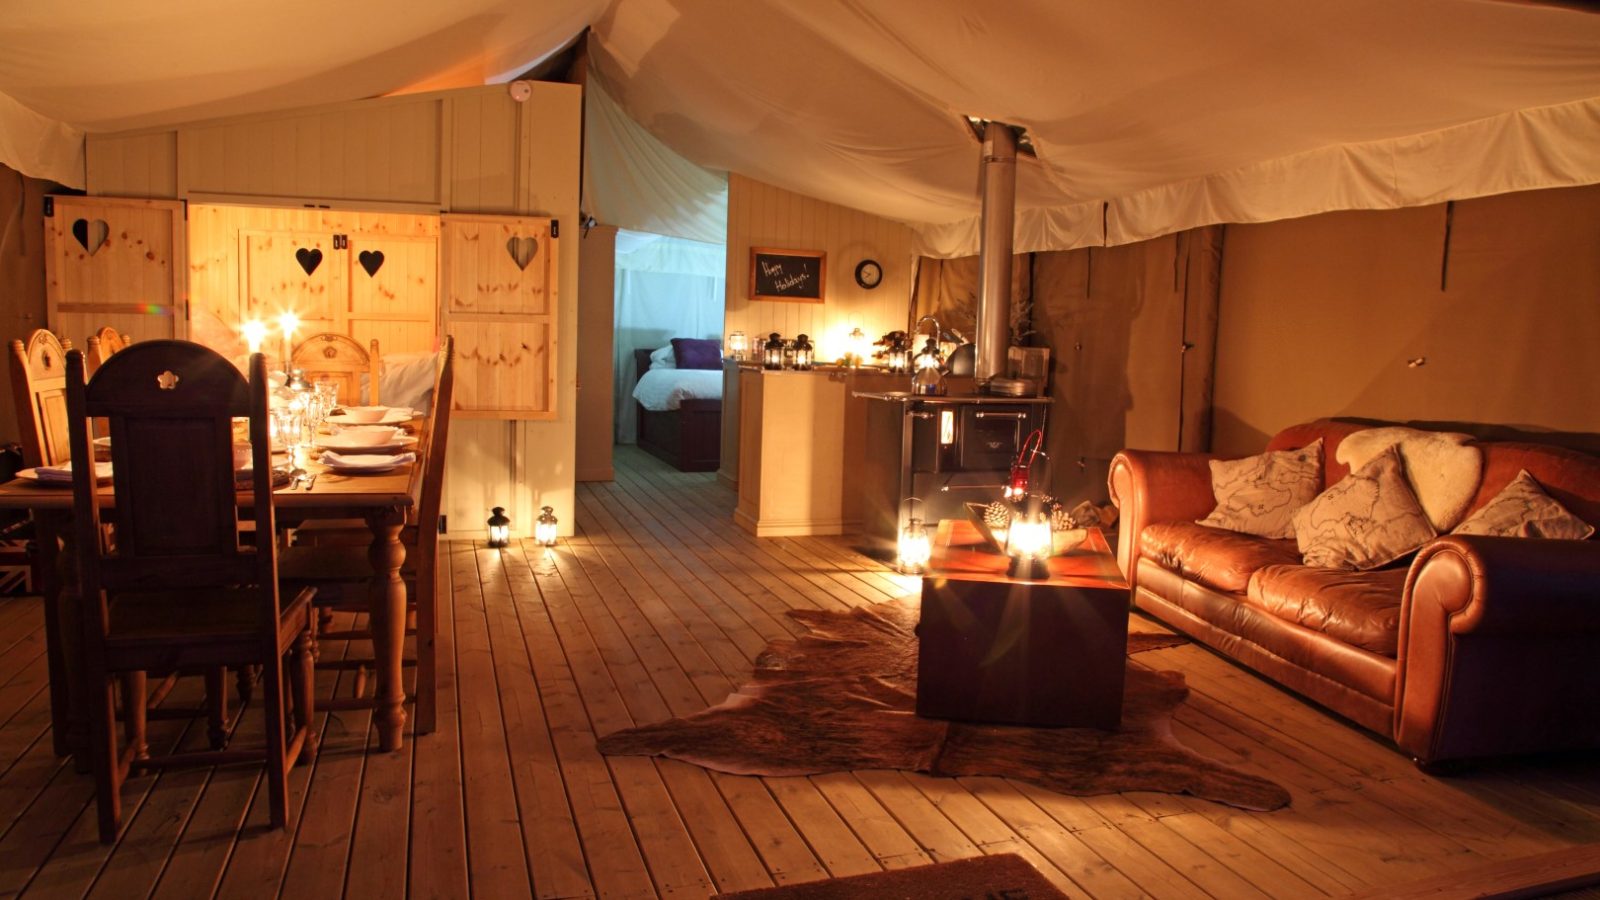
[1395,535,1600,762]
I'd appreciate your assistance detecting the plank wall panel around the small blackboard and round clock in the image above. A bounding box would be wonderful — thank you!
[723,175,914,362]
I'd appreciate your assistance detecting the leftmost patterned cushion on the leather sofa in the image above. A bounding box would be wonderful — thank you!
[1200,437,1322,538]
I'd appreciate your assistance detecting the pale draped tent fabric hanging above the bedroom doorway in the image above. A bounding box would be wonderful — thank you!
[584,78,728,243]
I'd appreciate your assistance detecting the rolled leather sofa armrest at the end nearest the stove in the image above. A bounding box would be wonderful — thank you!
[1106,450,1221,588]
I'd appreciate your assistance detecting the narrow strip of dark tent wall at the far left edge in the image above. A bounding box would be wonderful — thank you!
[0,165,54,444]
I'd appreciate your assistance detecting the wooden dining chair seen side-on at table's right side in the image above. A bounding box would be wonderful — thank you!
[278,336,456,735]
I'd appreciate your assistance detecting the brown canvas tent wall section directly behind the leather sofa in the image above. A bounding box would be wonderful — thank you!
[1213,187,1600,453]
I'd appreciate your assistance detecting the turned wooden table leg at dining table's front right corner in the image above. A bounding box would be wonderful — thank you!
[366,508,405,751]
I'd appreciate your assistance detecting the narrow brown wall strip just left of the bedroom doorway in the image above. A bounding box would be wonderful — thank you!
[576,226,616,482]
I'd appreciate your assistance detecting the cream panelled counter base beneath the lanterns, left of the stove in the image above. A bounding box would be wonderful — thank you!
[736,368,846,538]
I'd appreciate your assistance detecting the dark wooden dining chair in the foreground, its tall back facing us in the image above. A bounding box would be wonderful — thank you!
[66,341,317,842]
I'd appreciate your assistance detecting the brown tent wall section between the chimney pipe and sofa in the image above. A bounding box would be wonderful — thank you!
[1032,226,1222,506]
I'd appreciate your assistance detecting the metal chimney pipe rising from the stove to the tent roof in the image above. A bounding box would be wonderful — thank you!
[974,122,1016,388]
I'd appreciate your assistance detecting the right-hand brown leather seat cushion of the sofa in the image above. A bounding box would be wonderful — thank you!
[1245,565,1406,658]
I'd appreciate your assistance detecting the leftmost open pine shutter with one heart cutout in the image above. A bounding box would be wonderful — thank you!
[43,197,187,346]
